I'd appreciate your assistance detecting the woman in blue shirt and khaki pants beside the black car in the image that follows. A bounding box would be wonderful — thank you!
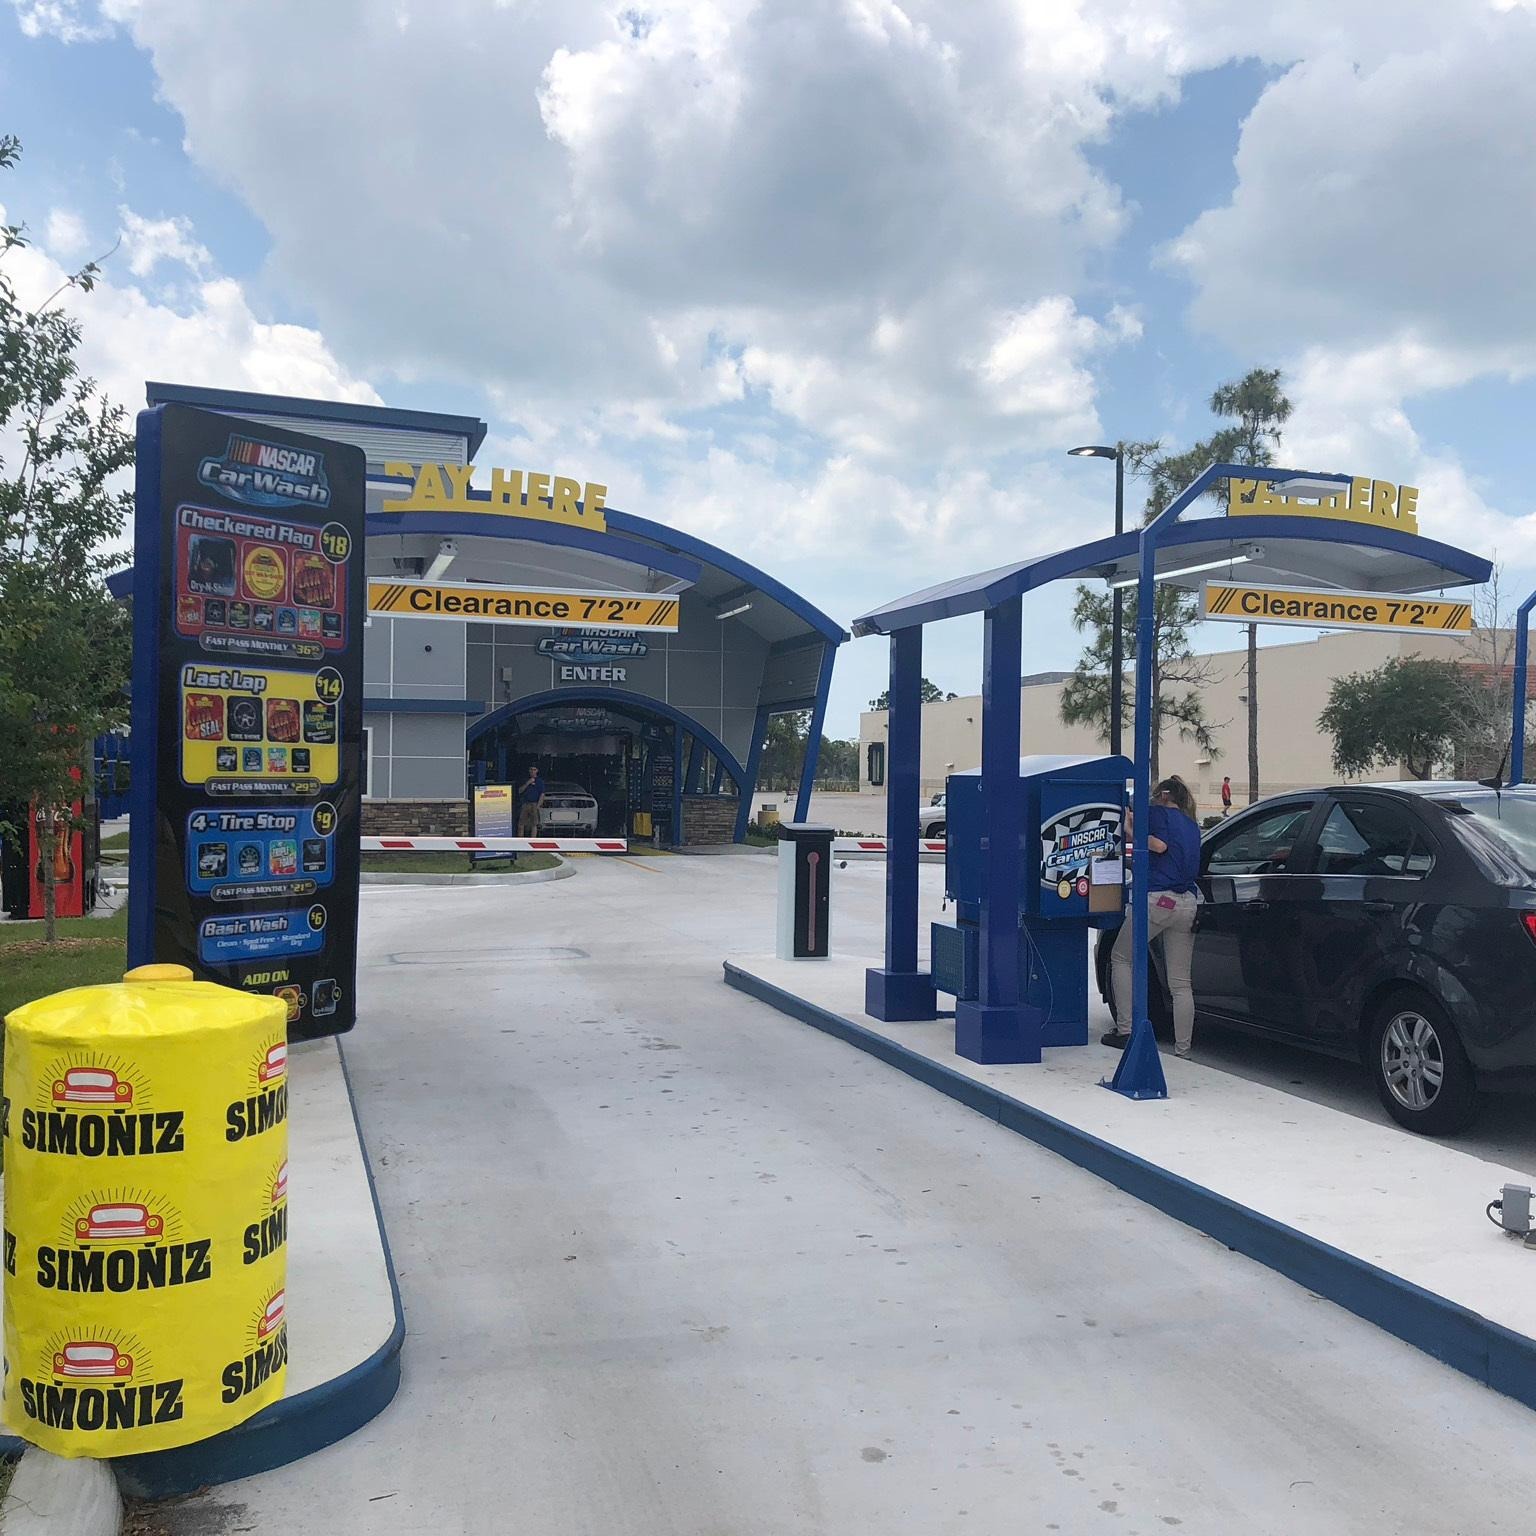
[1101,774,1200,1055]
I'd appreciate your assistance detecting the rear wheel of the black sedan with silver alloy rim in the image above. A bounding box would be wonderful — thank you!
[1367,991,1482,1137]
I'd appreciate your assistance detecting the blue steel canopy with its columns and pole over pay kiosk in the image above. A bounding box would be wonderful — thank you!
[852,464,1486,1075]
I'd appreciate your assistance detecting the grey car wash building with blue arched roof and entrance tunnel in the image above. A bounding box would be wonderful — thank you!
[124,384,846,846]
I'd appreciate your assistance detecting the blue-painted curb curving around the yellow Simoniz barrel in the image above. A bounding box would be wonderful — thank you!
[112,1040,406,1499]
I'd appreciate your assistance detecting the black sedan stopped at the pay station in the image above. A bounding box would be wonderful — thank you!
[1098,780,1536,1135]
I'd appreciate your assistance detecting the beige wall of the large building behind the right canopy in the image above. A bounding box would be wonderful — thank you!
[859,627,1467,814]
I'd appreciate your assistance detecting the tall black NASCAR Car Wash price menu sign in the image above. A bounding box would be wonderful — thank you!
[127,406,366,1040]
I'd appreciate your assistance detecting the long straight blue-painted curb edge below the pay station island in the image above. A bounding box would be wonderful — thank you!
[725,960,1536,1409]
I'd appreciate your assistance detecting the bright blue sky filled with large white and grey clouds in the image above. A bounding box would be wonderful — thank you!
[0,0,1536,734]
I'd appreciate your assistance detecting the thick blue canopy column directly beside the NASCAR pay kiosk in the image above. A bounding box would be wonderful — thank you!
[955,598,1044,1061]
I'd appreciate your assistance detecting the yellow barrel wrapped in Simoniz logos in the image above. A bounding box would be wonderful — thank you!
[3,965,287,1456]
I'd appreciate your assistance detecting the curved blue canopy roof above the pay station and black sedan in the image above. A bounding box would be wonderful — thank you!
[854,513,1493,634]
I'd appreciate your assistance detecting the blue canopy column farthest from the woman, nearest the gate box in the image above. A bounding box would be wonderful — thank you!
[865,628,933,1021]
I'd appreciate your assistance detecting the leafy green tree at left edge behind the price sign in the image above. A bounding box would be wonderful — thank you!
[0,135,134,942]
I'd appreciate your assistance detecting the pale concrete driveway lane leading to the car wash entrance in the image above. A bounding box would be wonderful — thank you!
[164,857,1536,1536]
